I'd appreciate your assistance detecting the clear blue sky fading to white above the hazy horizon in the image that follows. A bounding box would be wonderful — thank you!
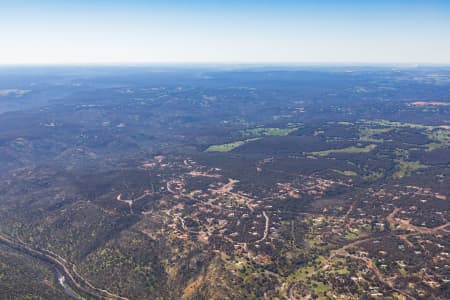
[0,0,450,64]
